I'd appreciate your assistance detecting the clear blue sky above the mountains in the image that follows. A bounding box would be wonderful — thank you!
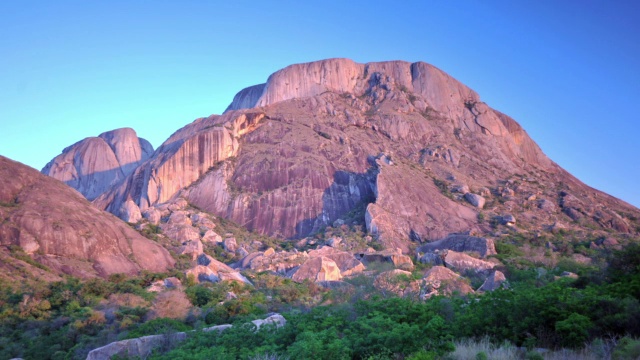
[0,0,640,206]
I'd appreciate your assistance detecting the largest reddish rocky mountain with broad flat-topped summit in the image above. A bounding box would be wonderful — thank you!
[80,59,640,252]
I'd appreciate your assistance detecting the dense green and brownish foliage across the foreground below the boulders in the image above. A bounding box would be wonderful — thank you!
[0,244,640,359]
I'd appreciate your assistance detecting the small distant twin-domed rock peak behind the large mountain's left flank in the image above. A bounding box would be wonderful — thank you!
[42,128,153,200]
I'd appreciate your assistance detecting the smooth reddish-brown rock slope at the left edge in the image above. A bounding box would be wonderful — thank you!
[0,156,174,278]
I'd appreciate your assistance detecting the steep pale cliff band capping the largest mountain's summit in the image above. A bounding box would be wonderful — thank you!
[227,59,479,116]
